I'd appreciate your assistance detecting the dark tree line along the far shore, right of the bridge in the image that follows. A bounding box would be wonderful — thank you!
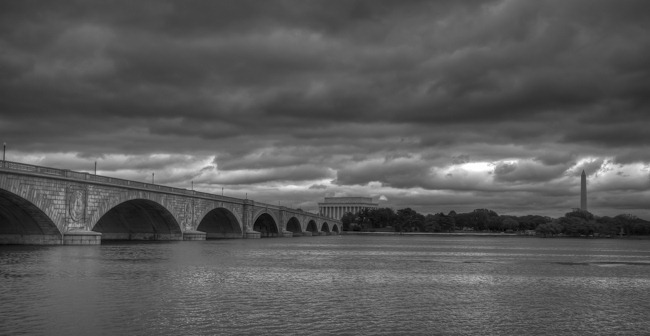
[341,208,650,237]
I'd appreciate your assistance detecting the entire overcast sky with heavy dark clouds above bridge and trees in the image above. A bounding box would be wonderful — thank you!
[0,0,650,219]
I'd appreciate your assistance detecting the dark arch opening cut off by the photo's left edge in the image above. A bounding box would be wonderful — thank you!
[0,189,63,244]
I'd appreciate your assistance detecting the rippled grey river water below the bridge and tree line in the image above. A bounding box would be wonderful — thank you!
[0,236,650,335]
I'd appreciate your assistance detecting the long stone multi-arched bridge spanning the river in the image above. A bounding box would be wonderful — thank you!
[0,161,341,245]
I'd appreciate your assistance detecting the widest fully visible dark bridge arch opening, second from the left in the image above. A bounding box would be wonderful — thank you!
[92,198,183,241]
